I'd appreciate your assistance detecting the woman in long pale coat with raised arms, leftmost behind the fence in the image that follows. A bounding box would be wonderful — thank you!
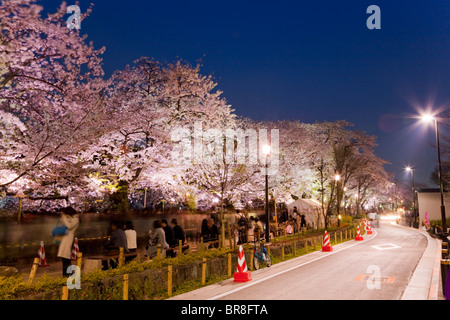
[58,207,80,276]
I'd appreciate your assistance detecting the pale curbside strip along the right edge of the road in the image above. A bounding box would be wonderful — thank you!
[391,222,442,300]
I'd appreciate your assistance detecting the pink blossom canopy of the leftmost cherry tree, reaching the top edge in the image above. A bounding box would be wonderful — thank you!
[0,0,110,205]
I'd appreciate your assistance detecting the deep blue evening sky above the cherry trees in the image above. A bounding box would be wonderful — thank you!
[41,0,450,184]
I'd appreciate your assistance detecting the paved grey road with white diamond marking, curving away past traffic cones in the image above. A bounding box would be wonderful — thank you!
[173,221,438,300]
